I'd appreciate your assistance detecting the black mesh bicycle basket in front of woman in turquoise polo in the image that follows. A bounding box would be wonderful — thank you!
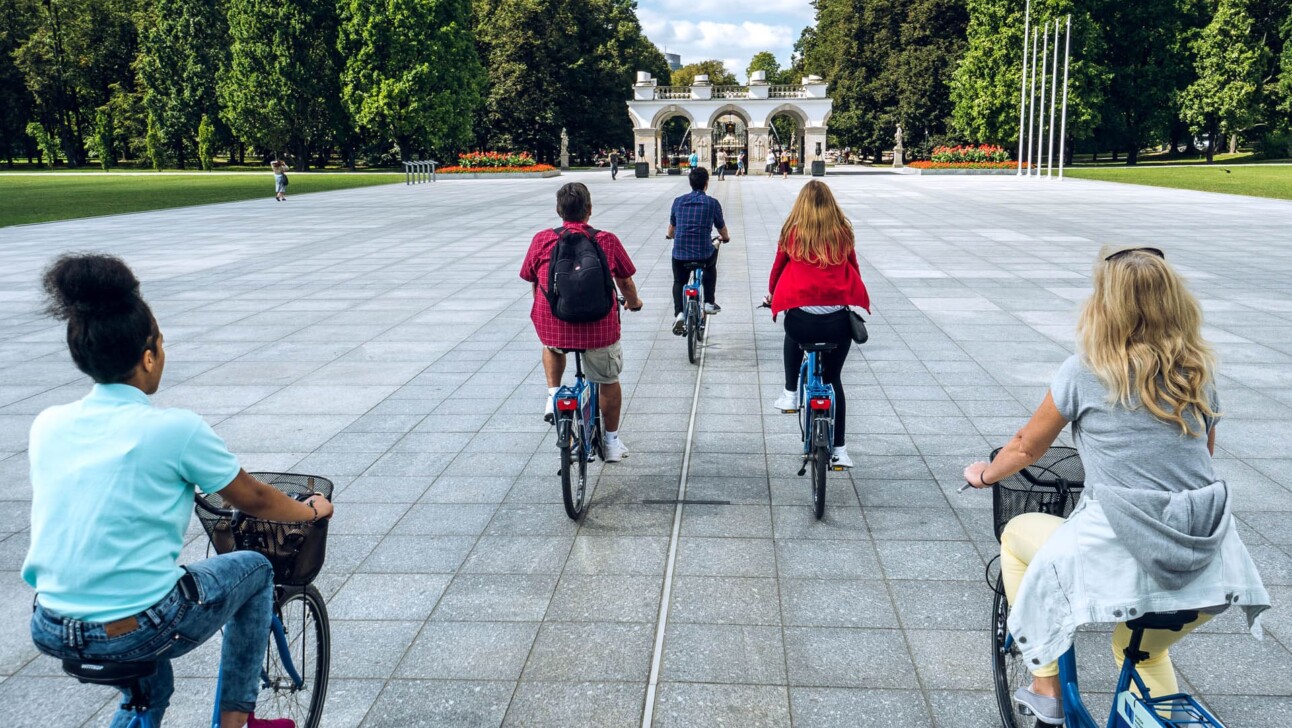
[196,473,332,586]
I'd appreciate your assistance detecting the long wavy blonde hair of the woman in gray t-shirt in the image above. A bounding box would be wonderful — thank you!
[1076,251,1218,437]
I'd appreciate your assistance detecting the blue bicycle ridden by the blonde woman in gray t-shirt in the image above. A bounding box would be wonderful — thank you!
[988,447,1224,728]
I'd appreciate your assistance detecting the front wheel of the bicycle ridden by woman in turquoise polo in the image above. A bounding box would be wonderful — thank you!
[256,584,332,728]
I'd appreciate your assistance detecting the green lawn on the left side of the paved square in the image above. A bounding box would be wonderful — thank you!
[0,172,404,228]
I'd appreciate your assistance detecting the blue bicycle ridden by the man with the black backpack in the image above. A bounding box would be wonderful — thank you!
[552,349,606,521]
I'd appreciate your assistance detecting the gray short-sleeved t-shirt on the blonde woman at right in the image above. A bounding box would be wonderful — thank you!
[1050,356,1220,498]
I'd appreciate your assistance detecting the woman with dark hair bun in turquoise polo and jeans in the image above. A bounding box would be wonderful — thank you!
[22,255,332,728]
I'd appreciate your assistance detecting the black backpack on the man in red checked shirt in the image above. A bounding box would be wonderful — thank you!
[543,228,615,323]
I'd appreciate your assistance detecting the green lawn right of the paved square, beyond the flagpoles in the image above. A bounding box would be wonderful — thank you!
[1063,164,1292,199]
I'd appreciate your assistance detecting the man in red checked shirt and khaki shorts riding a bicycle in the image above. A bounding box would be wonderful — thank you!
[521,182,642,463]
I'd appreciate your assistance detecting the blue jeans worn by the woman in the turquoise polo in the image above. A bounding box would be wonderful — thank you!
[31,551,274,728]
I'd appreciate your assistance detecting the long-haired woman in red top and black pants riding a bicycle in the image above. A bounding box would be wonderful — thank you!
[767,180,871,468]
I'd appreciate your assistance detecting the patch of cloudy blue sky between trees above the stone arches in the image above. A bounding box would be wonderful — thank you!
[637,0,813,83]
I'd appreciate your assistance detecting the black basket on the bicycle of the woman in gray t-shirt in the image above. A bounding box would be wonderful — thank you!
[991,447,1085,541]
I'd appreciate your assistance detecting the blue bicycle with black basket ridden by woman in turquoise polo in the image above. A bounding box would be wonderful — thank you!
[63,473,332,728]
